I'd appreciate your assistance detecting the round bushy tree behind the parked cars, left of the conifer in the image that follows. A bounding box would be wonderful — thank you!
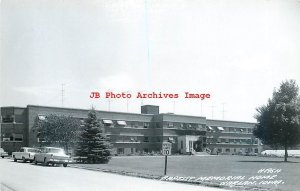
[34,114,80,152]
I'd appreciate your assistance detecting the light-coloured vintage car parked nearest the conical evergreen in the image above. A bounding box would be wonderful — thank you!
[33,147,71,167]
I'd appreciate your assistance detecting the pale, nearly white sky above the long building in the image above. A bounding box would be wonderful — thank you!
[0,0,300,122]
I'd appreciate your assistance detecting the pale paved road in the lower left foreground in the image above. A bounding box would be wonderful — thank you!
[0,159,225,191]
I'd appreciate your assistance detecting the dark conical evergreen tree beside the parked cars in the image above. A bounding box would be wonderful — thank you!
[76,109,111,163]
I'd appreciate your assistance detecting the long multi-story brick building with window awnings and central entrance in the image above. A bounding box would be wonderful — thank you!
[0,105,260,155]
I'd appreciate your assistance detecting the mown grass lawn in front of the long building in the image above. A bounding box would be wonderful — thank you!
[71,156,300,190]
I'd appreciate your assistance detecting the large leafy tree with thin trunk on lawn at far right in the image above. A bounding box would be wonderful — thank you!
[253,80,300,161]
